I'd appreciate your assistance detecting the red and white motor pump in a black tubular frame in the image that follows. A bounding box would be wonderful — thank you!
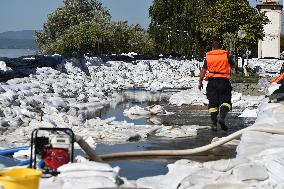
[30,128,75,175]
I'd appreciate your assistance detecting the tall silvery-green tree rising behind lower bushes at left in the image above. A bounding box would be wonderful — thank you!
[36,0,111,53]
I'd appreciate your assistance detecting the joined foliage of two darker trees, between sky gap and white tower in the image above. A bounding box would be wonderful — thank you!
[149,0,268,56]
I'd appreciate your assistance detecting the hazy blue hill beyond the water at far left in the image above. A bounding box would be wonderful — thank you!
[0,30,37,49]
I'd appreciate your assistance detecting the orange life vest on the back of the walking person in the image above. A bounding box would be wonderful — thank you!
[206,49,230,78]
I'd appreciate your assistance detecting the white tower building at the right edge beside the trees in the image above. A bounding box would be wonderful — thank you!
[256,0,283,58]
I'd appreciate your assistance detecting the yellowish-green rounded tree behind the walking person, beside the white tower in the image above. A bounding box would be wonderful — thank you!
[197,0,268,52]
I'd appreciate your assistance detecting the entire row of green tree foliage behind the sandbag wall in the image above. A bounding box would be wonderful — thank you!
[36,0,268,56]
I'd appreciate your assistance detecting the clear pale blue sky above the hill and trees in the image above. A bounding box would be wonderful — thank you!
[0,0,255,32]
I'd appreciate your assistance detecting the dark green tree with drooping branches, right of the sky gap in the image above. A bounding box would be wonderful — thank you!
[149,0,219,56]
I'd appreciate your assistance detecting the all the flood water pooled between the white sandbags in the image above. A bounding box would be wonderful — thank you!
[0,91,254,180]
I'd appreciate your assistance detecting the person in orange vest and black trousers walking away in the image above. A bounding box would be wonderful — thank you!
[198,41,235,131]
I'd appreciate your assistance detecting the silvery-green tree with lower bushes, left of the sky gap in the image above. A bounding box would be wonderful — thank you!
[36,0,153,54]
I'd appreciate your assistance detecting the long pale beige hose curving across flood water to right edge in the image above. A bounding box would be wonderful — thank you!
[99,126,284,160]
